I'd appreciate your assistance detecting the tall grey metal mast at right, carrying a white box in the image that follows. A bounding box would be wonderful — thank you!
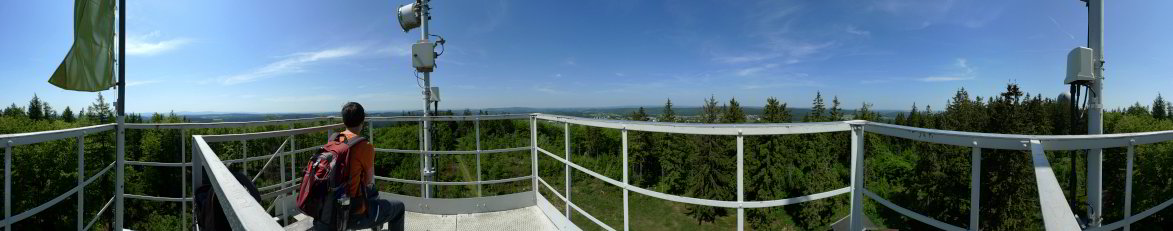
[1087,0,1104,227]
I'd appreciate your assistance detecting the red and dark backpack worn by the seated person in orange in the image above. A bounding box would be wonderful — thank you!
[297,134,366,230]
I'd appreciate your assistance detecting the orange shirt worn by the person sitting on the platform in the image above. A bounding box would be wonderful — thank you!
[343,130,374,213]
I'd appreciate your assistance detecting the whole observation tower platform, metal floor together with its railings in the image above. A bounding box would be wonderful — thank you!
[0,114,1173,231]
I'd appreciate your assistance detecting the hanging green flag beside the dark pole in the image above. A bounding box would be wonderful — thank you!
[49,0,116,91]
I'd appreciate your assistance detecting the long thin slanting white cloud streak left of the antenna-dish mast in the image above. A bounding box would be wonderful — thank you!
[219,47,359,84]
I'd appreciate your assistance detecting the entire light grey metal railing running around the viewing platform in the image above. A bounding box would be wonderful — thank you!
[0,114,1173,230]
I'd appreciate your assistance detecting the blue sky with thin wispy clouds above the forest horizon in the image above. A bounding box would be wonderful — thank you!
[0,0,1173,113]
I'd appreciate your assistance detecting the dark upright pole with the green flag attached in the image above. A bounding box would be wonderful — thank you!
[114,0,127,231]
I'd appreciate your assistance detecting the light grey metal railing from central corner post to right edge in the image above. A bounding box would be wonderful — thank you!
[530,114,1173,231]
